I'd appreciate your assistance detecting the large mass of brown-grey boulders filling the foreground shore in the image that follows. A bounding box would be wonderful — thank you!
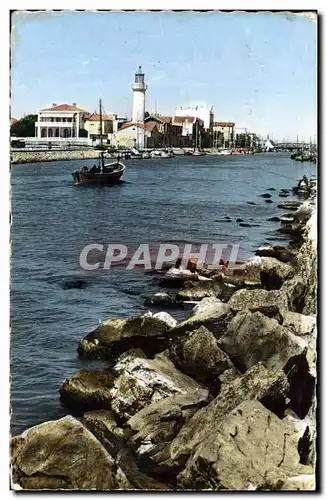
[12,181,317,491]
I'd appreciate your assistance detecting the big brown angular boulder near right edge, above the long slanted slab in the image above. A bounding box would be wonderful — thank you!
[219,310,307,370]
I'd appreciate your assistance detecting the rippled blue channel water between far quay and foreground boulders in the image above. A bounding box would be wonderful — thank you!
[11,153,315,435]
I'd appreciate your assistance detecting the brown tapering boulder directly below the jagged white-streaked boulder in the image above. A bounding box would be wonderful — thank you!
[127,389,208,477]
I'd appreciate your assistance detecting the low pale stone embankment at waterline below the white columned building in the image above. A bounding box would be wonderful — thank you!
[10,149,99,164]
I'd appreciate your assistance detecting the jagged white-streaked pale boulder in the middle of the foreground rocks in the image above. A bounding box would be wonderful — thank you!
[110,356,208,420]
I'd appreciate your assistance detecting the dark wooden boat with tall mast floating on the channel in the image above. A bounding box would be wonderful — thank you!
[72,99,126,186]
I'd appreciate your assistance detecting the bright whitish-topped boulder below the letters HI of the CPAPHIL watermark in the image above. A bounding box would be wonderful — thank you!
[171,298,232,339]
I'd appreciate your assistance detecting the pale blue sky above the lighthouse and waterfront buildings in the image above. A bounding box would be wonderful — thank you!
[11,11,317,140]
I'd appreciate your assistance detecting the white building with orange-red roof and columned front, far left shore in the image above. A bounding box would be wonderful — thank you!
[35,103,89,139]
